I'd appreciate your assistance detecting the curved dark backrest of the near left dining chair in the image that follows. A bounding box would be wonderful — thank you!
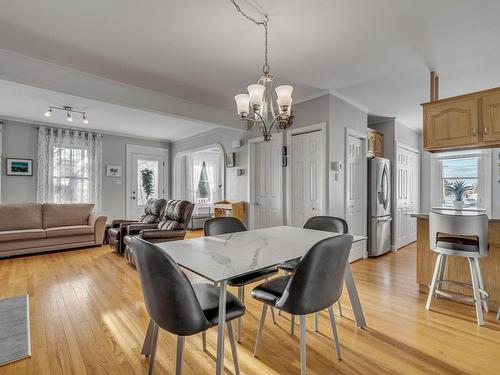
[130,236,209,336]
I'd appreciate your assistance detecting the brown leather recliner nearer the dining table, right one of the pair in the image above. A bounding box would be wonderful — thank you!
[124,200,194,264]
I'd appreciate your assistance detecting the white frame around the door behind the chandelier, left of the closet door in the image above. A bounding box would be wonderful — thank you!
[248,133,284,229]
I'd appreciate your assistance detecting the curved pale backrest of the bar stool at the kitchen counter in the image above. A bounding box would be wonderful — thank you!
[429,211,488,257]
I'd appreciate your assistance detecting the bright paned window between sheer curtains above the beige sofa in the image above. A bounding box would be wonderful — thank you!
[52,147,90,203]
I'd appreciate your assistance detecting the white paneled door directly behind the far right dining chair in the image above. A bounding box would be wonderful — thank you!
[290,130,326,227]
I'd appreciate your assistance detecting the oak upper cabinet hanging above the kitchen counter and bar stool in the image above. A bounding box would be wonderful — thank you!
[423,88,500,152]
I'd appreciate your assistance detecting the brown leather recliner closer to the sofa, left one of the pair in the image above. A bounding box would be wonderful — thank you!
[108,198,167,254]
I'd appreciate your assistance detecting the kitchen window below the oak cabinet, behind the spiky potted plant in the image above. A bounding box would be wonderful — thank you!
[431,150,491,212]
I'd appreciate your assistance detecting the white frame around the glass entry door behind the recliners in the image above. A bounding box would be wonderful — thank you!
[125,144,170,219]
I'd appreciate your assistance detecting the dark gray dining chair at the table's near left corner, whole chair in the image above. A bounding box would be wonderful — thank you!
[130,237,245,375]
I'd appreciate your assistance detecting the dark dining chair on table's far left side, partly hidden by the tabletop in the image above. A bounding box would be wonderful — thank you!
[203,216,278,342]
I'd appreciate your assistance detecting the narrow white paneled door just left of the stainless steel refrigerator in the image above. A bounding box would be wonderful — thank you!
[345,135,366,235]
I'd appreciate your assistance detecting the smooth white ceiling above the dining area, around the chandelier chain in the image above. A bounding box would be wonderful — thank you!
[0,0,500,129]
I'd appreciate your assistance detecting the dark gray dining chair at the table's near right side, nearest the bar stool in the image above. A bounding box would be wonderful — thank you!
[252,234,353,375]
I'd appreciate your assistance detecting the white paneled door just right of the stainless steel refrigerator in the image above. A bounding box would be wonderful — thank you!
[395,145,420,249]
